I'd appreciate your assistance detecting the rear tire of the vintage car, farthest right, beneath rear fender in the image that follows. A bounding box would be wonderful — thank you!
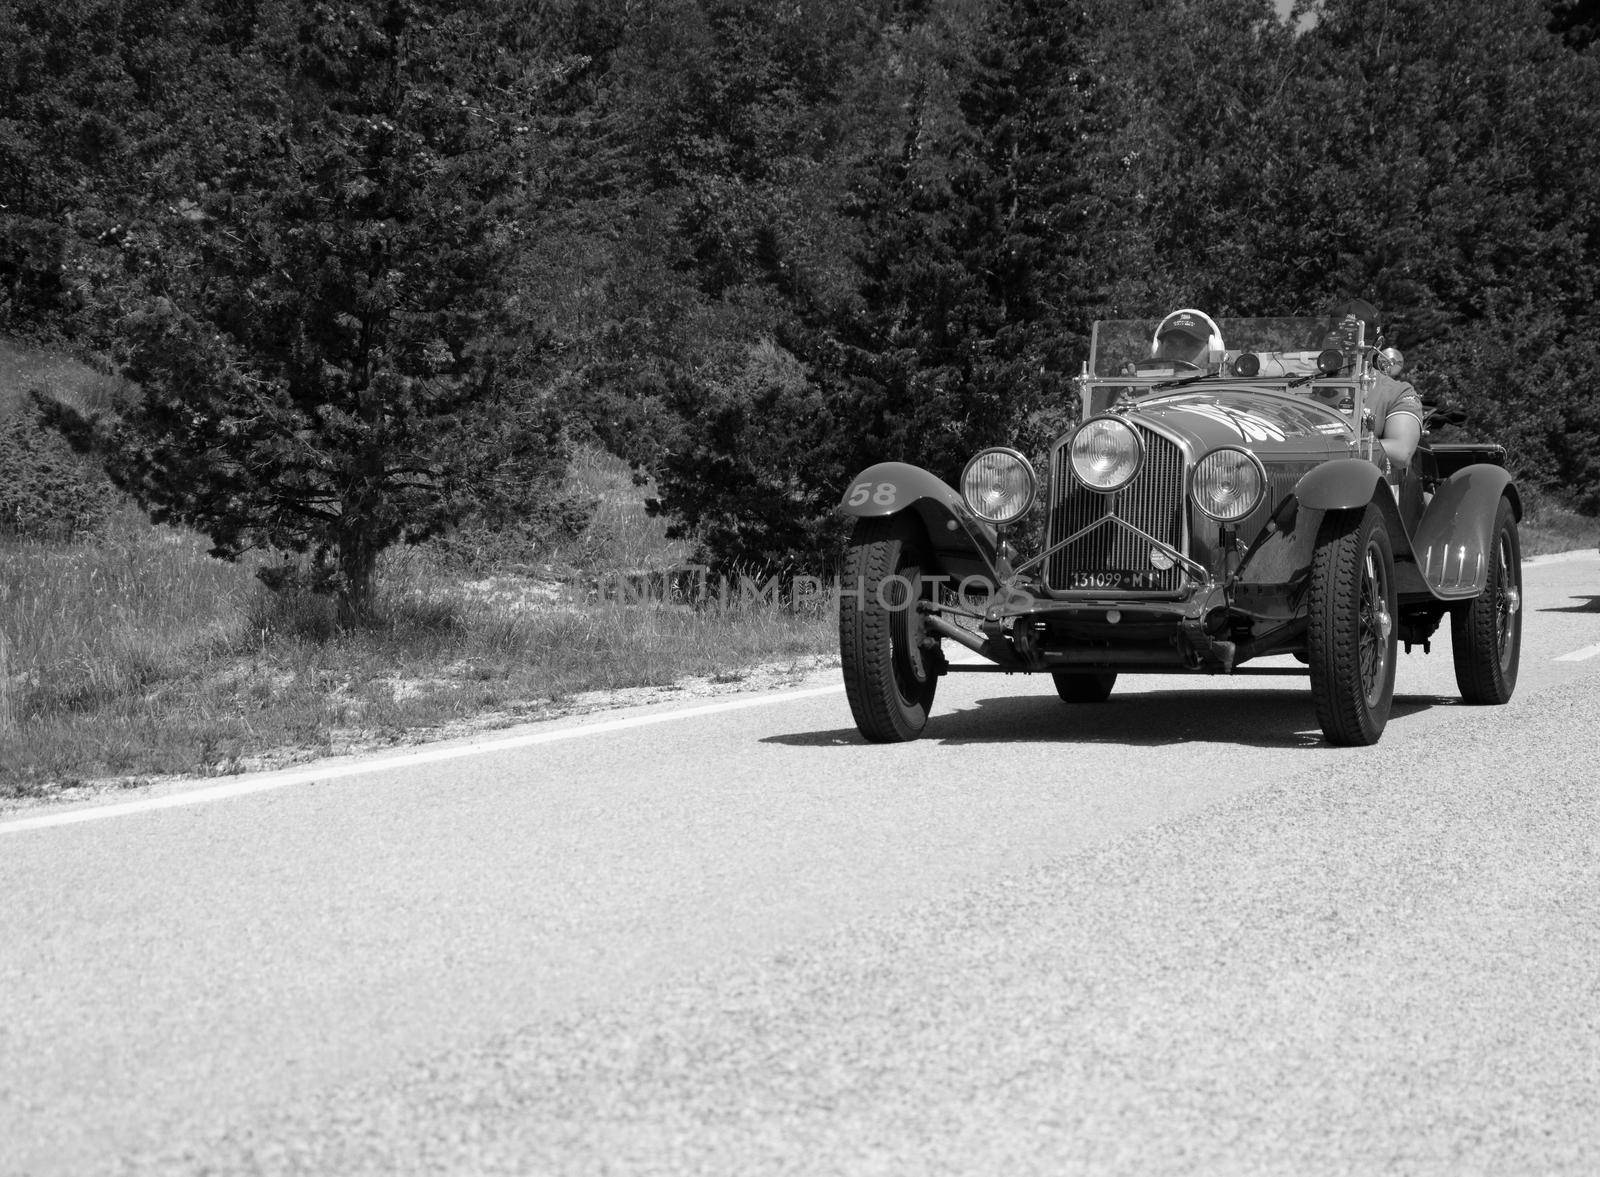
[1450,499,1522,704]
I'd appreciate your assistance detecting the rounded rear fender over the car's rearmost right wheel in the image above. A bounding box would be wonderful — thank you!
[1411,462,1522,600]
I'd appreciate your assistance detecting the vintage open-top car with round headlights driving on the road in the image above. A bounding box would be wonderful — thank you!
[838,318,1522,744]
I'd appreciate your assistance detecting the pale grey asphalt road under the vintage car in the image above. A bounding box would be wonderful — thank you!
[0,553,1600,1177]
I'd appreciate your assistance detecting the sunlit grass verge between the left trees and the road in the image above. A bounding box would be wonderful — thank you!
[0,453,837,801]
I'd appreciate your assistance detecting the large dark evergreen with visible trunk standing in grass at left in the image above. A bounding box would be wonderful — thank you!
[48,0,557,619]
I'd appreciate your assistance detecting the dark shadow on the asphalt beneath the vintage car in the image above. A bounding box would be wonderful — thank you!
[762,688,1459,748]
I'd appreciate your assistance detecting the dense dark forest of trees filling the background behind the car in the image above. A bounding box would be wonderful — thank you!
[0,0,1600,611]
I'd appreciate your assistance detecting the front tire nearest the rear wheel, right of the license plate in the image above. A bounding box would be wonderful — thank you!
[1306,505,1397,745]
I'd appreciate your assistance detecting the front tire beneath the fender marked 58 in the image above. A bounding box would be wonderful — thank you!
[838,518,939,744]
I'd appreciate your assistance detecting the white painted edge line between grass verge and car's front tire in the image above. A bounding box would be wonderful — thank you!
[0,683,845,835]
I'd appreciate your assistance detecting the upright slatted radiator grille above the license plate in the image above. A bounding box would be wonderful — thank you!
[1045,422,1189,592]
